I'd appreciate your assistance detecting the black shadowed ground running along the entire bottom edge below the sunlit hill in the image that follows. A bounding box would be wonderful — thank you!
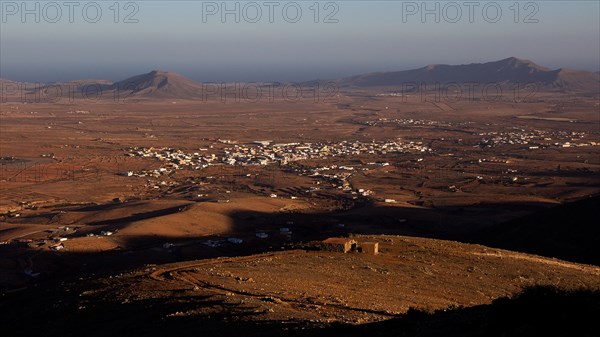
[1,286,600,337]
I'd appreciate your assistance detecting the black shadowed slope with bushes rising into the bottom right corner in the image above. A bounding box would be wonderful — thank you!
[314,286,600,337]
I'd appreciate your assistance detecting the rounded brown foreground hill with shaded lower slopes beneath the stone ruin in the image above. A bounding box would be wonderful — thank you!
[3,236,600,336]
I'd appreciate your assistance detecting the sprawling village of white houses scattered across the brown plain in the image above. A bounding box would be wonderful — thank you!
[120,122,600,198]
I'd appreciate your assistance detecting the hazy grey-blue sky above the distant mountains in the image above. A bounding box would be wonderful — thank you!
[0,0,600,82]
